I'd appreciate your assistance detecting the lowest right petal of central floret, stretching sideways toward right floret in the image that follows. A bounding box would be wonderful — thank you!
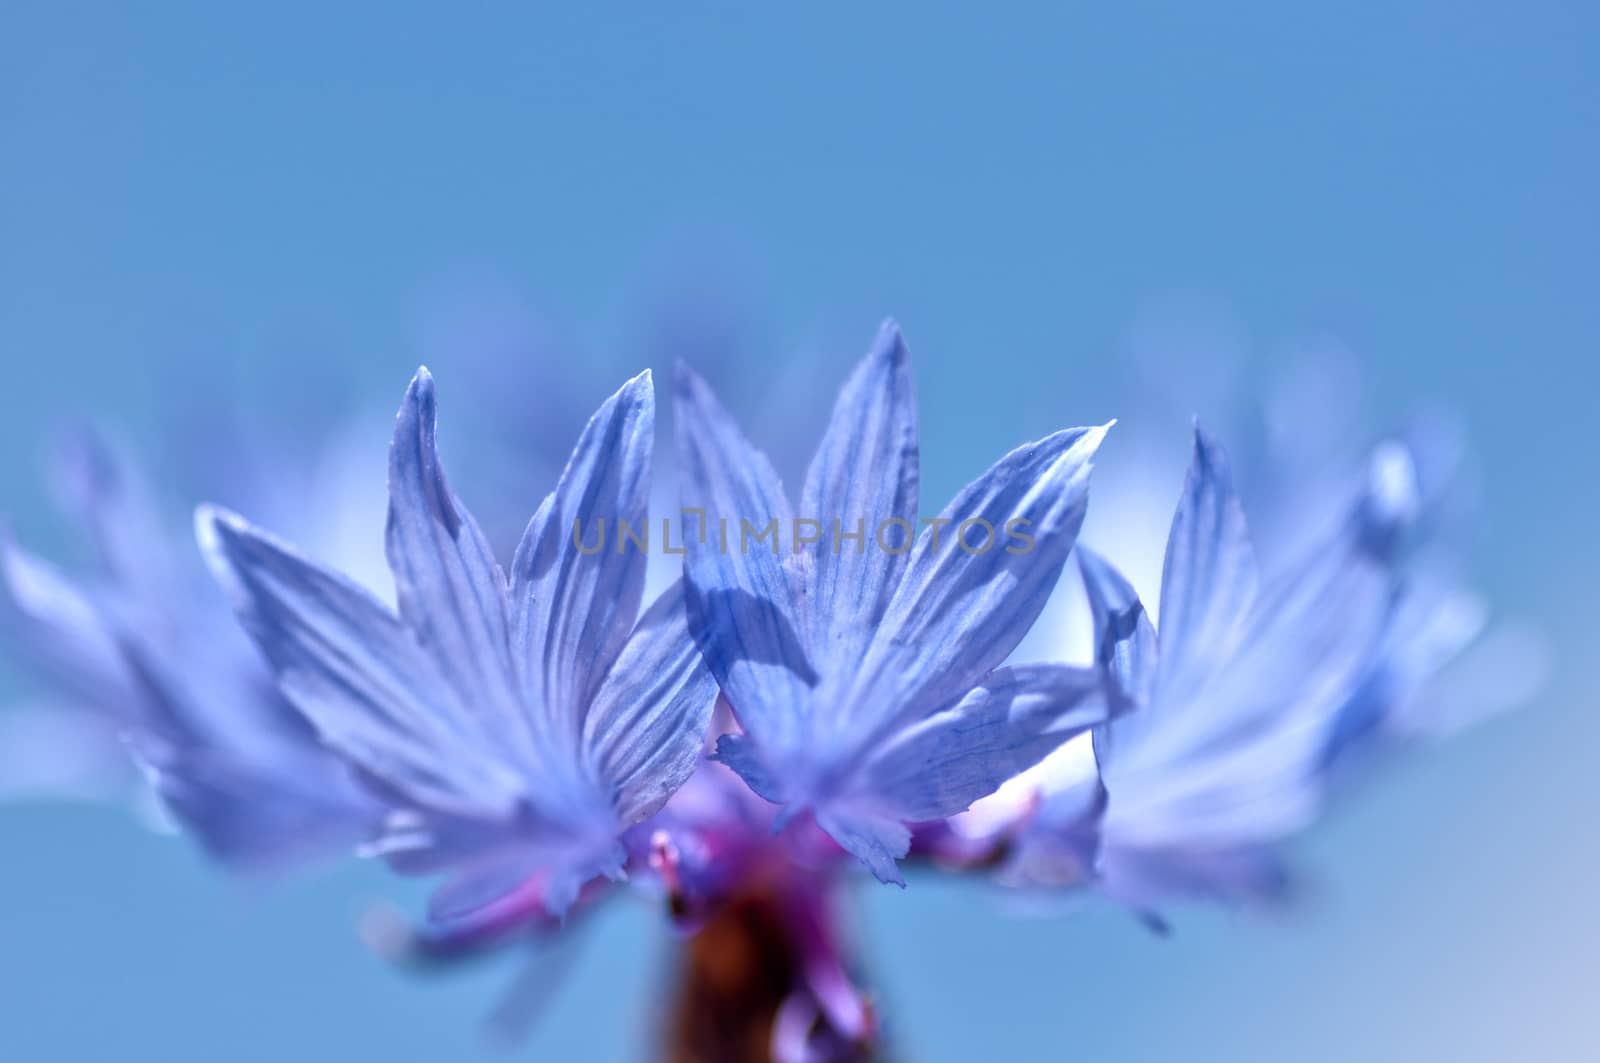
[861,664,1107,821]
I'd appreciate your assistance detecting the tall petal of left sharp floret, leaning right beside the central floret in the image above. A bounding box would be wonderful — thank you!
[510,370,656,733]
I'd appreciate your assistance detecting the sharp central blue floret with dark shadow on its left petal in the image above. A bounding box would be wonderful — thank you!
[675,323,1107,882]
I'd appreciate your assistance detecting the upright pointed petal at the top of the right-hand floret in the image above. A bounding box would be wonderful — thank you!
[1157,423,1258,698]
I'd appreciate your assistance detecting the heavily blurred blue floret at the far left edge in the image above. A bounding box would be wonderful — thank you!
[0,437,381,869]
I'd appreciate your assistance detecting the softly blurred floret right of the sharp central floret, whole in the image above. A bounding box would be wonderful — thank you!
[1046,426,1411,911]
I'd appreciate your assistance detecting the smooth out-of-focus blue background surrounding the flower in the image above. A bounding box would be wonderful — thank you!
[0,0,1600,1063]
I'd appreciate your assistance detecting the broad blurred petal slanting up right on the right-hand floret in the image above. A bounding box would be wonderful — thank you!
[1098,477,1395,848]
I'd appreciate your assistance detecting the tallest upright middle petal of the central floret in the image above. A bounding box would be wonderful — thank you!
[800,322,918,656]
